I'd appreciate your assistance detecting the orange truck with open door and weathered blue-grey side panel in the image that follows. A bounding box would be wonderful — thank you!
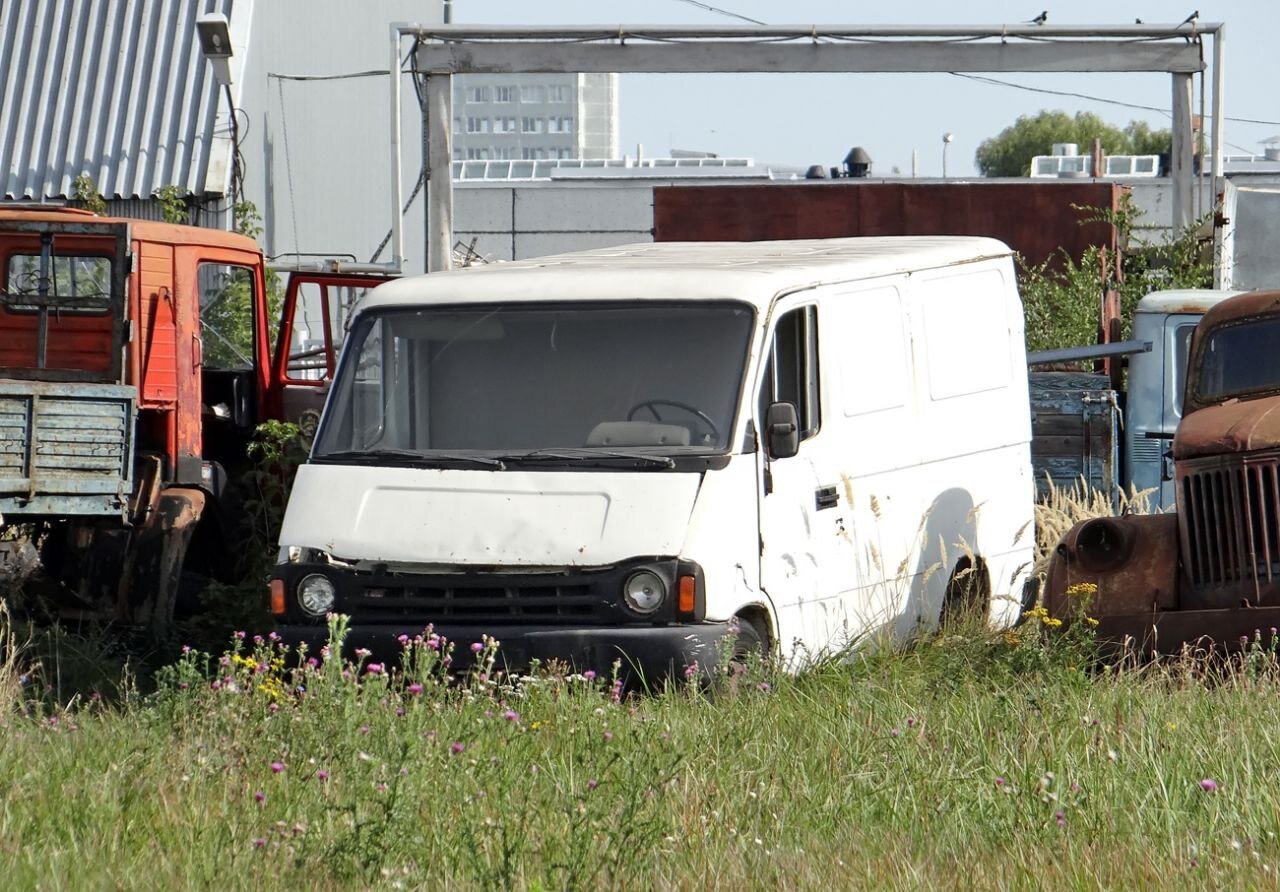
[0,206,389,628]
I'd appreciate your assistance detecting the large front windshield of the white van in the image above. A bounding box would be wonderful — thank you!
[312,301,754,467]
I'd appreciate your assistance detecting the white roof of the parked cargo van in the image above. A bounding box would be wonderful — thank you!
[361,235,1011,310]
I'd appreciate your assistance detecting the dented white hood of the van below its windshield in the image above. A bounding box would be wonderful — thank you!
[280,465,701,567]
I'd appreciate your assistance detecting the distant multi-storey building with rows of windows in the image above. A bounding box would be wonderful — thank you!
[453,74,618,161]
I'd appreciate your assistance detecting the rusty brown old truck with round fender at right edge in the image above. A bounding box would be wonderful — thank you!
[1044,291,1280,653]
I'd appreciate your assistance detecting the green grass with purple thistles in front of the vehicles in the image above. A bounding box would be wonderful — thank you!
[0,611,1280,889]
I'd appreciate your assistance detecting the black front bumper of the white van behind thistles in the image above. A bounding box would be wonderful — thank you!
[276,622,731,683]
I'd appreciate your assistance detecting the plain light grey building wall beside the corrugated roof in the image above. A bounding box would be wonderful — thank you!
[239,0,440,271]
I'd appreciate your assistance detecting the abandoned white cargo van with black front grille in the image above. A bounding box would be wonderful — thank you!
[271,237,1033,676]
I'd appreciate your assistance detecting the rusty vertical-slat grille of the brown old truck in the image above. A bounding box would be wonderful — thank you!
[1178,454,1280,593]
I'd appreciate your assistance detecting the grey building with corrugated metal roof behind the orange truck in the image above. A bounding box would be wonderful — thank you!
[0,0,440,266]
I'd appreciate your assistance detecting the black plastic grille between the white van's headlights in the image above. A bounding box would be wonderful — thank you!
[349,585,600,623]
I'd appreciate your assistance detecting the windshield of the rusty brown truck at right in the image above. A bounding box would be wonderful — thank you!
[1196,316,1280,402]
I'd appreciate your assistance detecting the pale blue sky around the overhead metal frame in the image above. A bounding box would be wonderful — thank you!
[453,0,1280,177]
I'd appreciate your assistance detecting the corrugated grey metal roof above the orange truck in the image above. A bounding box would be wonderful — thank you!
[0,0,232,222]
